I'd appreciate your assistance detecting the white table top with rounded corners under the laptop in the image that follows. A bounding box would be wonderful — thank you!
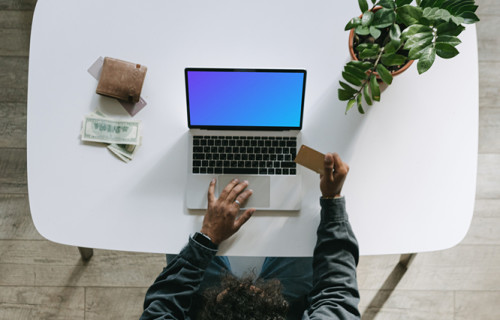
[27,0,478,256]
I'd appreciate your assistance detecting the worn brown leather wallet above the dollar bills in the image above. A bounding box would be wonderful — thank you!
[96,57,148,103]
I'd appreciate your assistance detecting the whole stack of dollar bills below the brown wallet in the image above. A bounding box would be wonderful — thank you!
[81,111,142,163]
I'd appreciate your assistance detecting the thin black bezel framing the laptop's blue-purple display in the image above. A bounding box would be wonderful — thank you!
[184,68,307,131]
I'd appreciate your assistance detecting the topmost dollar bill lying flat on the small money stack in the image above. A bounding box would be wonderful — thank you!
[81,115,141,145]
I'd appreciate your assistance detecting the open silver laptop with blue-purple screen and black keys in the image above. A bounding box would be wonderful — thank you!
[184,68,306,210]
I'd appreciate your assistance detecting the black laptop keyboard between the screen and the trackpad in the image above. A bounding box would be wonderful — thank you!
[193,136,297,175]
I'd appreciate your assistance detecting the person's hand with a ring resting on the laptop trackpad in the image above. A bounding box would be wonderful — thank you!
[200,179,255,245]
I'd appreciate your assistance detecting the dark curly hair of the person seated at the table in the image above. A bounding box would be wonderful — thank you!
[197,274,288,320]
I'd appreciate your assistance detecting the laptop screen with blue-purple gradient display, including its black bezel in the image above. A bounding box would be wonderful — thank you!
[185,68,306,130]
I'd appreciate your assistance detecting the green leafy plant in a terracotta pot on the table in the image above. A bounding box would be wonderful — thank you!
[338,0,479,114]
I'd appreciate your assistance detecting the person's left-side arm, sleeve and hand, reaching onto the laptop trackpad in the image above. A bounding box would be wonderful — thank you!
[141,179,255,320]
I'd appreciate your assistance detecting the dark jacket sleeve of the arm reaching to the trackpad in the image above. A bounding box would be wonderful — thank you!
[140,237,217,320]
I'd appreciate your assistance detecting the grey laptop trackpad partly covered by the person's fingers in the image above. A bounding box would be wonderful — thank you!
[216,175,271,208]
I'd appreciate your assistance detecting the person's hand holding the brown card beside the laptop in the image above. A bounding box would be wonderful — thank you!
[319,153,349,198]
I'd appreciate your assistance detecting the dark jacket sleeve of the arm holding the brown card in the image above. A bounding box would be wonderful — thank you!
[302,198,360,320]
